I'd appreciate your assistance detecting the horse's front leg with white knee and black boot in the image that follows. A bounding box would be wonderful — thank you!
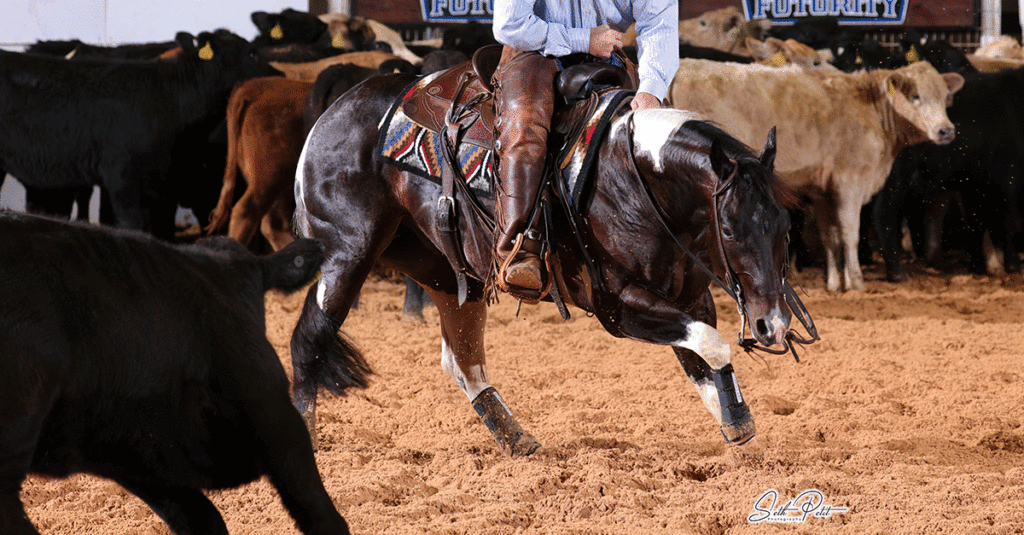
[620,285,755,444]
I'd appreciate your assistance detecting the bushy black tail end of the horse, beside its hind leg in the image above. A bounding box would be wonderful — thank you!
[292,284,373,396]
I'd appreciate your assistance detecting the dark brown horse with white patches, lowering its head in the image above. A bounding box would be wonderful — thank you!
[291,68,816,456]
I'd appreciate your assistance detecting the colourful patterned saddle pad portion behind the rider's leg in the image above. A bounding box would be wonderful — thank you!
[377,75,497,198]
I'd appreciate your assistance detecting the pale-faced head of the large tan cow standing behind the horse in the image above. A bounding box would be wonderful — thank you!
[879,61,964,145]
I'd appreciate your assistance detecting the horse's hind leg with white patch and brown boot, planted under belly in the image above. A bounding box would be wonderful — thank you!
[429,291,541,457]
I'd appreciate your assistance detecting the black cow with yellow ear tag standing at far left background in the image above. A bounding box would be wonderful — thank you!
[0,30,280,238]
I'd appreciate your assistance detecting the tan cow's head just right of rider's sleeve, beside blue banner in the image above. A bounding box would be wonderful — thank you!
[679,6,771,57]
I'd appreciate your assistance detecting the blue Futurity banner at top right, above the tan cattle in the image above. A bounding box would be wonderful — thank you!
[741,0,909,25]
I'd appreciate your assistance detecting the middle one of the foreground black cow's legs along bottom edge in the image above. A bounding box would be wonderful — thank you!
[117,480,227,535]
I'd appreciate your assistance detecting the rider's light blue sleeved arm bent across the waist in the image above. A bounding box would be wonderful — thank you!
[494,0,589,56]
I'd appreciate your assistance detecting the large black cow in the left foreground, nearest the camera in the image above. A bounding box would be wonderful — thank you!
[0,212,356,535]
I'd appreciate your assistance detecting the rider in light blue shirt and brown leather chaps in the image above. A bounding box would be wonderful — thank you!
[493,0,679,298]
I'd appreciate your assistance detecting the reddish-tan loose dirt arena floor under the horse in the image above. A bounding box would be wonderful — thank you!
[23,260,1024,535]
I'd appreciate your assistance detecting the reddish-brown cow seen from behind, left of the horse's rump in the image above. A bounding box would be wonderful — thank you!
[206,77,313,251]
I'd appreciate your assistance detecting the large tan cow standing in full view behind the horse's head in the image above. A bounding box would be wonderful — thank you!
[669,59,964,291]
